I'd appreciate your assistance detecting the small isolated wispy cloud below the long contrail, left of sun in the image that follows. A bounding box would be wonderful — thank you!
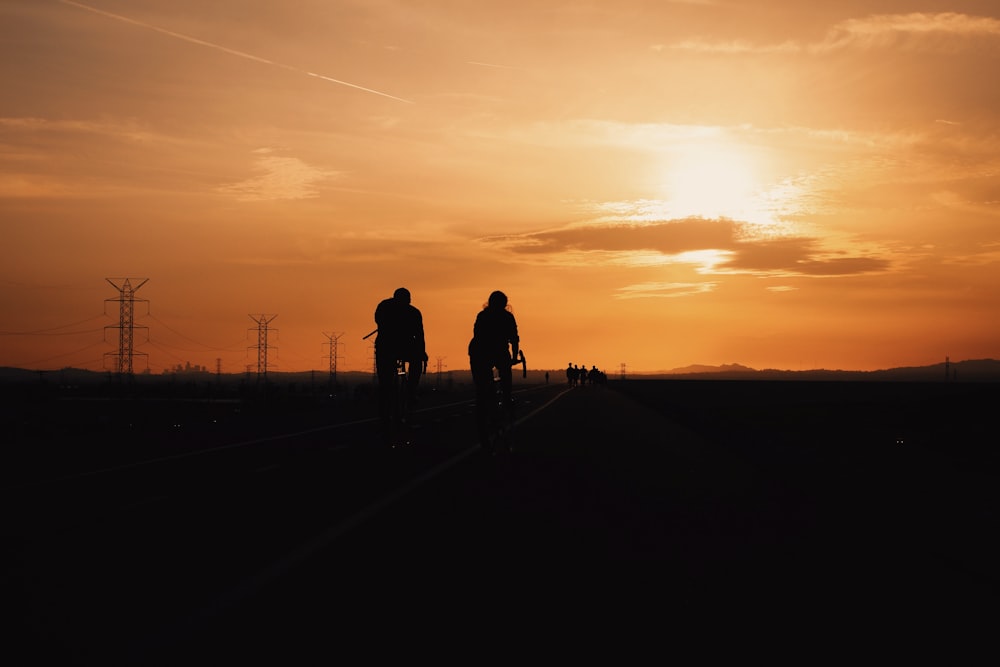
[218,149,340,201]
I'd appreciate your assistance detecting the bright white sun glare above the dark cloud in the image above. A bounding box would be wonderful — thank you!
[664,142,771,223]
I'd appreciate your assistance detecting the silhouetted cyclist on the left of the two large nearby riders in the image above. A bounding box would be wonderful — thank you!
[375,287,428,421]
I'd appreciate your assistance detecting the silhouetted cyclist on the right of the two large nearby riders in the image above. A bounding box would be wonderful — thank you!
[469,290,520,447]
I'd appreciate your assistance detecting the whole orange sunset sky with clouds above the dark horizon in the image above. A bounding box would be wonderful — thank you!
[0,0,1000,373]
